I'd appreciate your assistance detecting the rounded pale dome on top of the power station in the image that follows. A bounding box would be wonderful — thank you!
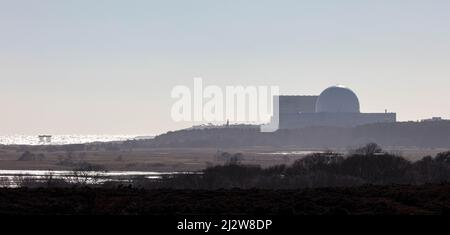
[316,86,359,113]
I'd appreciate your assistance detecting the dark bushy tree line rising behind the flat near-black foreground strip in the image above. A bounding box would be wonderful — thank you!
[141,144,450,189]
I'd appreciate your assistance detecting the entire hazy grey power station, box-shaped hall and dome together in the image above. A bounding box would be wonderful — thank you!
[272,86,397,129]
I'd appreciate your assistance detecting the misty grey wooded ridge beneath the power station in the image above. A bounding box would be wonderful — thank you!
[131,121,450,148]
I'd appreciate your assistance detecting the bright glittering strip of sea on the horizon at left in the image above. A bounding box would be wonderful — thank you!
[0,135,153,145]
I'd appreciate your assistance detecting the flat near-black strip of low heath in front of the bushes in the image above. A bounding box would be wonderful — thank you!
[0,184,450,216]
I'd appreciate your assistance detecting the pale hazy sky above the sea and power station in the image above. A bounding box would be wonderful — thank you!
[0,0,450,135]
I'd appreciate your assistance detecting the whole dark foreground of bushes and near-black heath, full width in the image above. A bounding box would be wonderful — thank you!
[0,144,450,216]
